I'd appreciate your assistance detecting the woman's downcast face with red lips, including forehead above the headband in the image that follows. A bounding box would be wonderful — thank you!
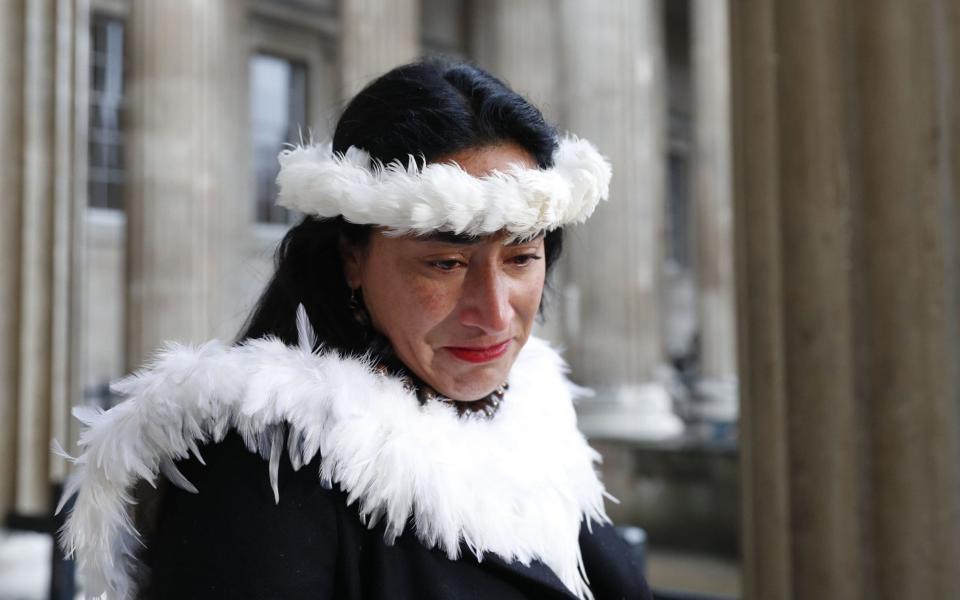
[344,144,546,400]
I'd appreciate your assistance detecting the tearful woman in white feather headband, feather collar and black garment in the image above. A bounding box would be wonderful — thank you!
[64,62,649,599]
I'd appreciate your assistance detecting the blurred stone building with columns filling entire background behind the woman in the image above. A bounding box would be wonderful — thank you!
[0,0,960,600]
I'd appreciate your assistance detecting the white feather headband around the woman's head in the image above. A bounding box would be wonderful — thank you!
[277,136,611,238]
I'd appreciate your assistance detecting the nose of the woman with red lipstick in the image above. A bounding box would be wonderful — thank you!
[460,266,513,334]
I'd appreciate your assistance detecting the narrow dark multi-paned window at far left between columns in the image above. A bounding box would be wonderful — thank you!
[87,15,124,210]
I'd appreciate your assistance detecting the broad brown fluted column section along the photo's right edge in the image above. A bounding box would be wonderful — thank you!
[848,0,960,600]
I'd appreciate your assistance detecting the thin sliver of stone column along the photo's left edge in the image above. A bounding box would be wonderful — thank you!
[0,2,24,517]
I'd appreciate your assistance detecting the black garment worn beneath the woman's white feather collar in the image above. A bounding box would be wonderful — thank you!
[139,433,650,600]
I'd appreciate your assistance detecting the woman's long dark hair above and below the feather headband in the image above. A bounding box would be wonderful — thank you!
[240,60,563,354]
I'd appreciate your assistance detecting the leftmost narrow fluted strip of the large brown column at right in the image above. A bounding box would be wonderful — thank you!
[730,0,799,600]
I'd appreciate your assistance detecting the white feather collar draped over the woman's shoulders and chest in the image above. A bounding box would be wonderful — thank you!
[58,334,609,599]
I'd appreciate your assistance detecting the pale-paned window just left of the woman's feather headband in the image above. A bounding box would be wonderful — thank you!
[250,53,309,224]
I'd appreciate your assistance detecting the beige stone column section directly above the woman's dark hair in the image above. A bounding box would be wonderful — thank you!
[340,0,420,100]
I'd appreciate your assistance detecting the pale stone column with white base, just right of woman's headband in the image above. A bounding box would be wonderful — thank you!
[560,0,680,437]
